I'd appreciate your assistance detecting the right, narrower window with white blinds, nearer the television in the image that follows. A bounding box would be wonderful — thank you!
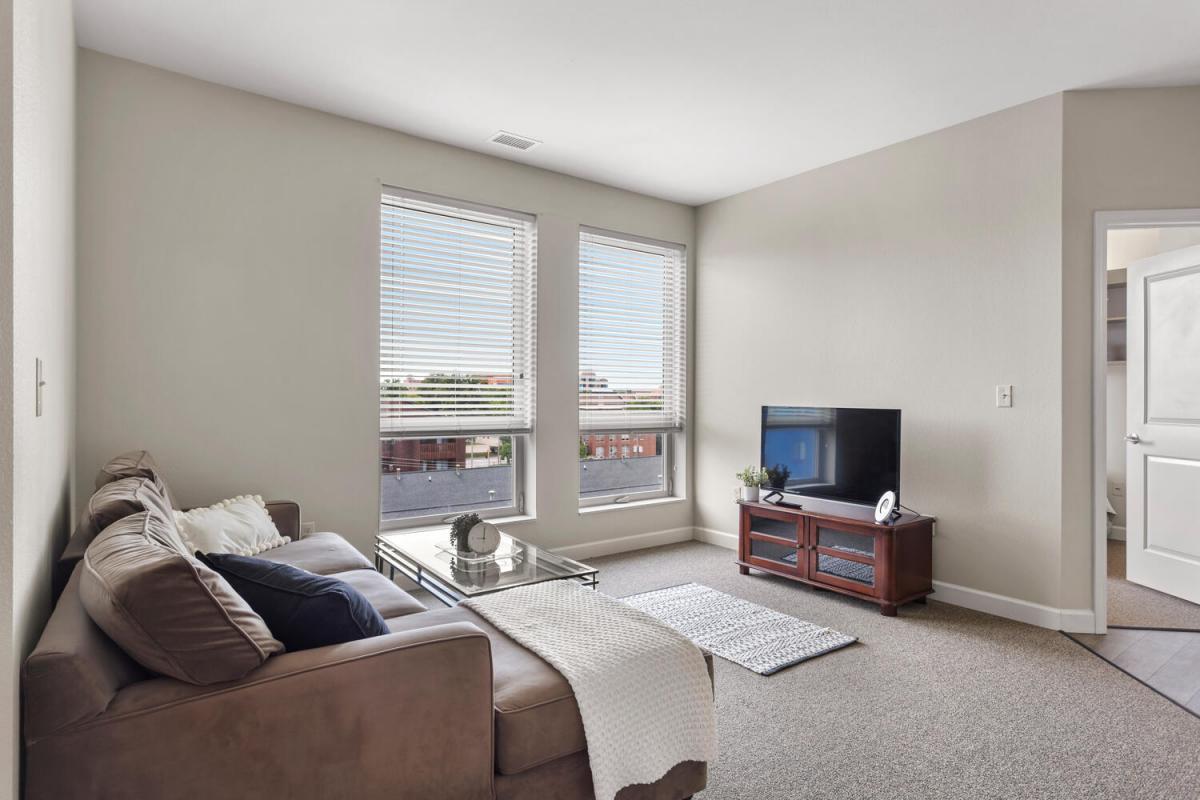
[580,229,688,505]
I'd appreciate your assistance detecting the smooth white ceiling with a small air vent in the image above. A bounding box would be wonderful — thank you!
[76,0,1200,204]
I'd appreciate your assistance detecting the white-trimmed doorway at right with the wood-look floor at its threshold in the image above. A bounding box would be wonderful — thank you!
[1067,210,1200,716]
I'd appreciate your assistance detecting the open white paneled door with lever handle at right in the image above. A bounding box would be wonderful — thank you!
[1126,241,1200,603]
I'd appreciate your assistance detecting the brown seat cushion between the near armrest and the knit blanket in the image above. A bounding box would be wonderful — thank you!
[388,607,587,775]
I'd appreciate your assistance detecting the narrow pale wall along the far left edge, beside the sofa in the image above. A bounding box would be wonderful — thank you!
[0,0,76,798]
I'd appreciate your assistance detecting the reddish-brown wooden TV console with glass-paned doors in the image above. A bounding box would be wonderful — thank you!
[738,499,934,616]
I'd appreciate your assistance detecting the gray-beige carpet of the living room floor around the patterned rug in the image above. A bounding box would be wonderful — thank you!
[588,542,1200,800]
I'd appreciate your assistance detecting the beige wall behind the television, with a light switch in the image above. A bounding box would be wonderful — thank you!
[695,96,1070,607]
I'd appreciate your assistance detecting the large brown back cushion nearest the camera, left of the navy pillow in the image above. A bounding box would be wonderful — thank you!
[79,511,283,685]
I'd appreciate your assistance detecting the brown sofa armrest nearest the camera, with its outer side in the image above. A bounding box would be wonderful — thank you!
[25,622,494,800]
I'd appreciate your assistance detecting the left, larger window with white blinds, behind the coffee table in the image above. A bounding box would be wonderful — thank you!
[379,190,536,527]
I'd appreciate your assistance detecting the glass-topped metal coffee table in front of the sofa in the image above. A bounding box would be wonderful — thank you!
[376,529,600,606]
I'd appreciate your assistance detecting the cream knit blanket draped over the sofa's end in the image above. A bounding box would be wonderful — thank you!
[462,581,716,800]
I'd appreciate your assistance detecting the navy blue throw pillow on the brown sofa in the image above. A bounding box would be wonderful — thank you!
[196,553,389,651]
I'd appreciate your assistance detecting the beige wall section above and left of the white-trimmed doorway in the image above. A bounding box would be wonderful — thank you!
[1062,88,1200,607]
